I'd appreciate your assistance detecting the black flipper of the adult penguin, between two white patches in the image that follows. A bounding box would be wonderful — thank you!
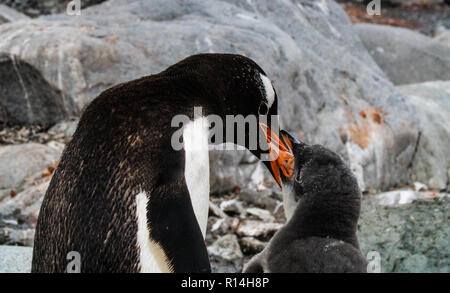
[147,178,211,273]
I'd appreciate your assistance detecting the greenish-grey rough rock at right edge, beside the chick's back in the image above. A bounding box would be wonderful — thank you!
[358,196,450,273]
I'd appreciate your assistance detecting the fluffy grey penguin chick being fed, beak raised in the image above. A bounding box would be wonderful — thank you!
[244,131,367,273]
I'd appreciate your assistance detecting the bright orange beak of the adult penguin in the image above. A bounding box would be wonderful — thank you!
[259,122,294,187]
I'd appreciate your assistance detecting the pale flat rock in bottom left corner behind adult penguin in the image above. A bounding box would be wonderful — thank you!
[0,245,33,273]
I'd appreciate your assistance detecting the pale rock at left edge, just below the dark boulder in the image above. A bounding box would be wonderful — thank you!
[0,143,60,201]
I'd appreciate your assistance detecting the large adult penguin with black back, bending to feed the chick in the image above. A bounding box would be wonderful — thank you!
[32,54,292,272]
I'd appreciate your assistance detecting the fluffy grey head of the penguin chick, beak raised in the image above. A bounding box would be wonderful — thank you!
[281,130,361,219]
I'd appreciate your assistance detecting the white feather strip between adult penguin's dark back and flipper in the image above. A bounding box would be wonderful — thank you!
[136,192,173,273]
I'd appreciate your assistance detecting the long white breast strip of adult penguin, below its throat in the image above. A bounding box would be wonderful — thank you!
[183,117,209,238]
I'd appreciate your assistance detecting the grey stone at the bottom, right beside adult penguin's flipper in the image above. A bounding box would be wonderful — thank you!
[208,234,244,273]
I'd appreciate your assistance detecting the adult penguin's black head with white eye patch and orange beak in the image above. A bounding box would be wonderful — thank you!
[207,55,294,187]
